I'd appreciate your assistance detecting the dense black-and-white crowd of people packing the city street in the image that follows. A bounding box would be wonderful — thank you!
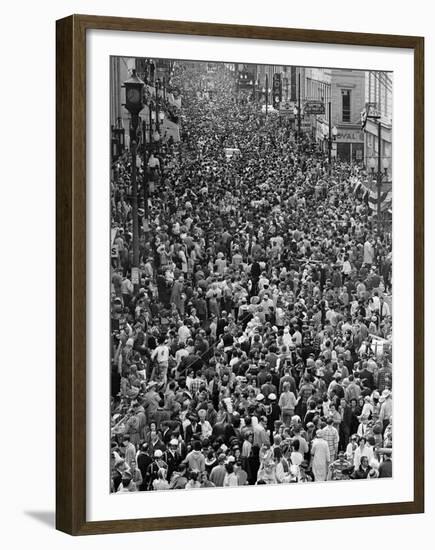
[111,64,392,492]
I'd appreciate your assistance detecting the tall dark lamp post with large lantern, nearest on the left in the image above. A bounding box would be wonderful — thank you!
[124,69,144,293]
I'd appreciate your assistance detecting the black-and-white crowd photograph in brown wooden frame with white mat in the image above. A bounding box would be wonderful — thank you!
[56,15,424,535]
